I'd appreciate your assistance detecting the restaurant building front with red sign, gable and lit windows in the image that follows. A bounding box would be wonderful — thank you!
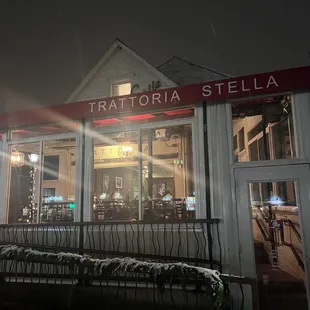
[0,41,310,309]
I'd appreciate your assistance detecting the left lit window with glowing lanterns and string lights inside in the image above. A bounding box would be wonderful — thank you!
[8,133,76,223]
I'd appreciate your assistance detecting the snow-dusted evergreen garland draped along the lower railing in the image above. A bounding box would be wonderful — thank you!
[0,245,224,307]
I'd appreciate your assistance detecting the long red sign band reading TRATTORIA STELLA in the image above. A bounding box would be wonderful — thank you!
[0,67,310,128]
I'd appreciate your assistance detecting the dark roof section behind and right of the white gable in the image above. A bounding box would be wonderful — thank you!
[157,56,229,85]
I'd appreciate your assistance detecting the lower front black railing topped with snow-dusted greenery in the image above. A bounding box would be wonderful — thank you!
[0,246,258,309]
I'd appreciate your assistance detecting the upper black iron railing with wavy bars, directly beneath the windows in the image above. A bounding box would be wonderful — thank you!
[0,219,222,270]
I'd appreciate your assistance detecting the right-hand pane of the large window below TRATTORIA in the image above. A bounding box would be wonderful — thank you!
[142,125,195,220]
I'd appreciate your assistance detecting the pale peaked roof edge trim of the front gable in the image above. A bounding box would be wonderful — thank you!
[66,39,177,103]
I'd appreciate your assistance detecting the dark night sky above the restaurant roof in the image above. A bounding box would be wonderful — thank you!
[0,0,310,104]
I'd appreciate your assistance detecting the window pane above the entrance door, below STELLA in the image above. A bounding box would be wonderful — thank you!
[232,96,296,162]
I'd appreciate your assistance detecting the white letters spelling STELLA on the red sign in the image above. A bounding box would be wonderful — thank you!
[202,75,279,97]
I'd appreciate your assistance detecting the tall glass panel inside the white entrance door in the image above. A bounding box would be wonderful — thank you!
[249,181,307,309]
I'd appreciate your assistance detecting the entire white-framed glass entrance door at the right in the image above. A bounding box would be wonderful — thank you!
[235,165,310,309]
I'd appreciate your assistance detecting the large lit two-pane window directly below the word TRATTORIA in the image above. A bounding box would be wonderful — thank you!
[93,115,196,221]
